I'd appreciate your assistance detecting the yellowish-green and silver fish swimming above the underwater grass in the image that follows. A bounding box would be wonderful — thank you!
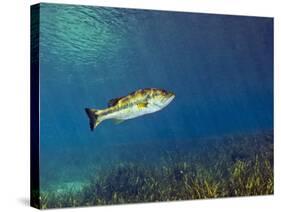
[85,88,175,131]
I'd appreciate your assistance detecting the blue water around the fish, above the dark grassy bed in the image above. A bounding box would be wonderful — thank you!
[40,4,273,192]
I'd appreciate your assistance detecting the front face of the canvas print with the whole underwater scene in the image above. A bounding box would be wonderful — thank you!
[33,3,274,209]
